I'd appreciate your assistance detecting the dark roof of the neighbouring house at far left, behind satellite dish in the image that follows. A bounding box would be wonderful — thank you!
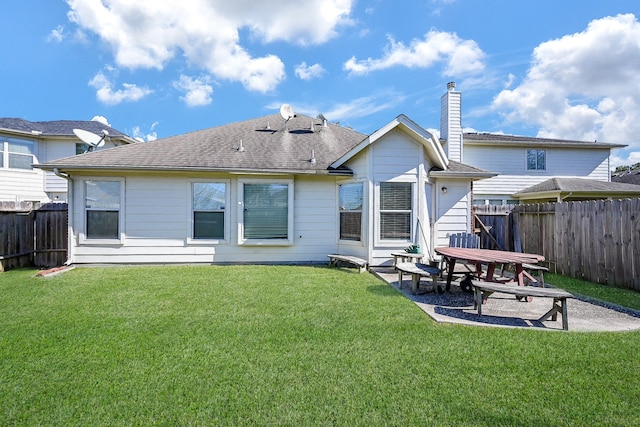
[0,117,136,143]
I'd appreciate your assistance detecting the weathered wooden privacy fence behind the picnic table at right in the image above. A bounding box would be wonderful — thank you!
[474,198,640,290]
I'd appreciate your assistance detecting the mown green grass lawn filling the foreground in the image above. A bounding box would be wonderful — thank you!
[0,266,640,427]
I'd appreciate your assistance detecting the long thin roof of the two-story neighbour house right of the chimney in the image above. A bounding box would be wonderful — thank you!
[463,132,626,149]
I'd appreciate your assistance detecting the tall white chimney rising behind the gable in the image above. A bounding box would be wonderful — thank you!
[440,82,463,162]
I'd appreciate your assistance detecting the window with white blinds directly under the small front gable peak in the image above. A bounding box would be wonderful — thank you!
[380,182,413,240]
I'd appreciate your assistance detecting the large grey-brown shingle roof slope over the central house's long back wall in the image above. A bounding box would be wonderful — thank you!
[39,114,366,173]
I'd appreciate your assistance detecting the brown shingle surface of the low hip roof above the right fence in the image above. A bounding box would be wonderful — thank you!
[516,178,640,195]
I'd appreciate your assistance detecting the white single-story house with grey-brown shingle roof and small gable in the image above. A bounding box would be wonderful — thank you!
[36,109,495,265]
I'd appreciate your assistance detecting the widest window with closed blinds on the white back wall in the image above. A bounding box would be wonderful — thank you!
[240,181,293,244]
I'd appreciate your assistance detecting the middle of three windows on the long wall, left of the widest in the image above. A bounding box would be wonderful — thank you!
[191,182,227,240]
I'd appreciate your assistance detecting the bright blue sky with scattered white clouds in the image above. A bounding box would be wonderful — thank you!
[0,0,640,166]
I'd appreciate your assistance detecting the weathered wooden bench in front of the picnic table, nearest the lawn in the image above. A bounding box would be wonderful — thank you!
[472,280,573,331]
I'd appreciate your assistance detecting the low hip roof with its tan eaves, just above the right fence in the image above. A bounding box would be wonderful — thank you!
[513,178,640,200]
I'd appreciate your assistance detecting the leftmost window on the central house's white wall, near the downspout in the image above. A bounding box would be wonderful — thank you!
[84,181,122,240]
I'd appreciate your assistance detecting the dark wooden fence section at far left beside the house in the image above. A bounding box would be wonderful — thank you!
[0,202,68,272]
